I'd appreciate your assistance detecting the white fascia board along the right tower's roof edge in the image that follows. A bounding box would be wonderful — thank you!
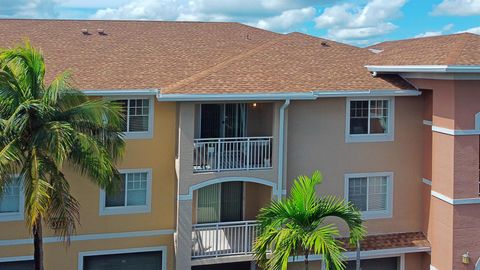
[365,65,480,73]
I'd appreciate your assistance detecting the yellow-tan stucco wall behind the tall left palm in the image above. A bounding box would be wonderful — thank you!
[0,102,176,269]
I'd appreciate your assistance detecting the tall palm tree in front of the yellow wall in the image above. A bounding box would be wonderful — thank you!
[0,41,125,270]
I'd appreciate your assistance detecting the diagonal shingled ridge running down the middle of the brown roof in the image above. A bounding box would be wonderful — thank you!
[161,35,288,92]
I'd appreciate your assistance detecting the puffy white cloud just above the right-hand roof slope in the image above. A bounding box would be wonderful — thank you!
[315,0,406,44]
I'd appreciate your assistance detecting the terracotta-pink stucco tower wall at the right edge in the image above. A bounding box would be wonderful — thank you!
[410,79,480,270]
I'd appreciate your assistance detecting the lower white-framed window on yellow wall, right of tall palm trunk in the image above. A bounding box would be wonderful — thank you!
[100,170,152,215]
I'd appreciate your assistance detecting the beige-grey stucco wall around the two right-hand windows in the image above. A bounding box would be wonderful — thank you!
[287,97,423,234]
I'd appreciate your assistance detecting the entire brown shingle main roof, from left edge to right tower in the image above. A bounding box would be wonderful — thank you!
[0,19,413,94]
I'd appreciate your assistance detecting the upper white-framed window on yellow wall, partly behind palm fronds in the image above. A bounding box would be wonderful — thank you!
[117,99,153,139]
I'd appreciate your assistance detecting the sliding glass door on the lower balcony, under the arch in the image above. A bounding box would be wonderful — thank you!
[197,182,243,224]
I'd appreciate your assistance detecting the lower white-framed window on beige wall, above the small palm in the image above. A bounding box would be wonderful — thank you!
[345,173,393,219]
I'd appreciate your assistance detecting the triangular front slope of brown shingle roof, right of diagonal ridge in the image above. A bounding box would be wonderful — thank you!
[162,33,413,94]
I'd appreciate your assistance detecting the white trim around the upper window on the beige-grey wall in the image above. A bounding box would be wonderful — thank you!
[345,97,395,143]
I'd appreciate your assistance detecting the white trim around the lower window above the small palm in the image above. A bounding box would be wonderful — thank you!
[344,172,393,220]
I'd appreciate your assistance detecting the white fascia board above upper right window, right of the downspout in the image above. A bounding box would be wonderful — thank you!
[313,89,422,98]
